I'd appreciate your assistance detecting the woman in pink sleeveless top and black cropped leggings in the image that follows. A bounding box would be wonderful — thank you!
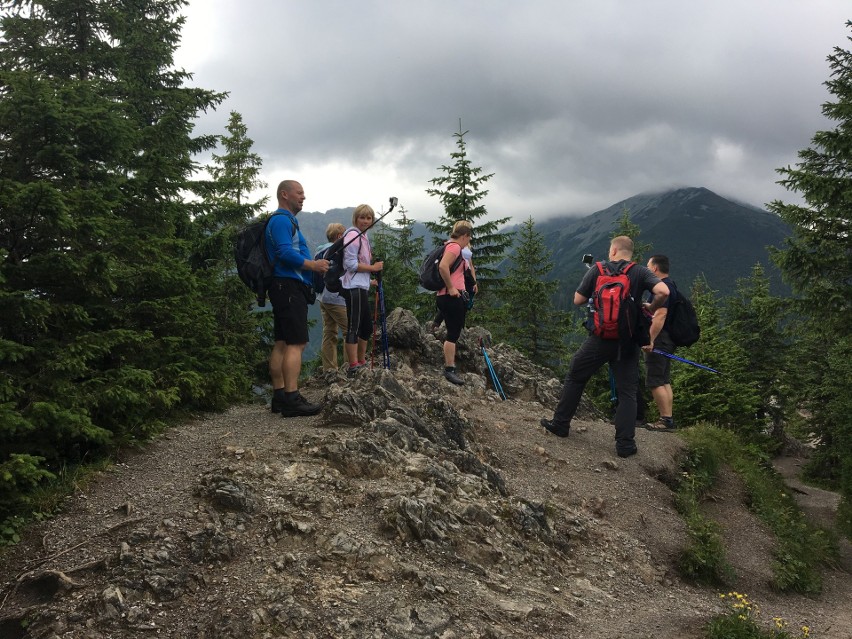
[436,220,473,386]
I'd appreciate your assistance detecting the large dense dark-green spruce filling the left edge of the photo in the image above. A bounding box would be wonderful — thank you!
[0,0,226,519]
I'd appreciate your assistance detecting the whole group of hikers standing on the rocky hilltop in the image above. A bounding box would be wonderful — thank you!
[255,180,697,457]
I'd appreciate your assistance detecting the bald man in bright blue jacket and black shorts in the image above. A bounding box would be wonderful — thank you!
[266,180,328,417]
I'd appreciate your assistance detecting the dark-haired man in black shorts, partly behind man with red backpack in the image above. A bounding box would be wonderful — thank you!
[642,255,677,432]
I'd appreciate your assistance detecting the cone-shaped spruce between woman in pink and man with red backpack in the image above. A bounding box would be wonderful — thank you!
[493,217,571,369]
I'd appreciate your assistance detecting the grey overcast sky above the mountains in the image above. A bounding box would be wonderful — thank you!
[176,0,852,222]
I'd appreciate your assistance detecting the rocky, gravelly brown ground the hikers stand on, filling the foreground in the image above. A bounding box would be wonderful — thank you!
[0,311,852,639]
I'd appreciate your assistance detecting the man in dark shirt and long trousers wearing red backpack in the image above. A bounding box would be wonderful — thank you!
[541,235,668,457]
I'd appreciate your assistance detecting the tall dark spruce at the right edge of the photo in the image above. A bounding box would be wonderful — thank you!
[768,21,852,530]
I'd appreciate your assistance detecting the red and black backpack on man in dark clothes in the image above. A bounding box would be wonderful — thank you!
[589,262,638,340]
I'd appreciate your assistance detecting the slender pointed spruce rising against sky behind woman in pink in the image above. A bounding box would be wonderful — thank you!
[424,122,512,292]
